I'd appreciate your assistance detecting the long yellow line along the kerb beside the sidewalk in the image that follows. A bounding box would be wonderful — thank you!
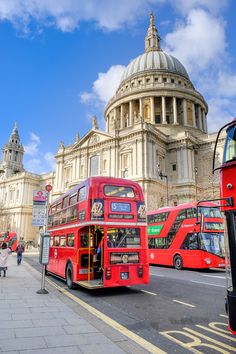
[47,279,167,354]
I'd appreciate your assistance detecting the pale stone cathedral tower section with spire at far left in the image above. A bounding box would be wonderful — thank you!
[0,124,53,242]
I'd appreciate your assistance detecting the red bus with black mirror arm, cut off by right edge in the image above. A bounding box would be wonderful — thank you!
[213,118,236,335]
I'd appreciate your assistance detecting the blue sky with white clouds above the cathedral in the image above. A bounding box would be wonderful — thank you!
[0,0,236,173]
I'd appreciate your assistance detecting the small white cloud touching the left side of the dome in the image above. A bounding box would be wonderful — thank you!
[79,65,125,105]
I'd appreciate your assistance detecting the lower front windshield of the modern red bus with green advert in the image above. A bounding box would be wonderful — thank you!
[199,233,225,257]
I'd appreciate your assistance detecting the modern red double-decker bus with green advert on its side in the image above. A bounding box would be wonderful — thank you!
[147,203,225,270]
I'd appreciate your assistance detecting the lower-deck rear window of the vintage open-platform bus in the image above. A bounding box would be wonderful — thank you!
[107,228,140,248]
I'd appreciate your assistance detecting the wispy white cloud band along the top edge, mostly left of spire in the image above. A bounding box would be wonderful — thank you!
[0,0,163,32]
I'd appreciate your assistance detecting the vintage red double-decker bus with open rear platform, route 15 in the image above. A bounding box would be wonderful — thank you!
[47,177,149,289]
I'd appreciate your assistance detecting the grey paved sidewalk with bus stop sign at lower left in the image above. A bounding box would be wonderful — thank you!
[0,255,152,354]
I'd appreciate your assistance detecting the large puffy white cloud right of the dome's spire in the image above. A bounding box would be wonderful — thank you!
[164,9,226,77]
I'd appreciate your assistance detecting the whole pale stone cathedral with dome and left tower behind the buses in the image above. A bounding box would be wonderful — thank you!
[0,15,224,240]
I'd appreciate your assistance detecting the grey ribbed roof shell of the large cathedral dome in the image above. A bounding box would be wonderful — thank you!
[121,50,189,82]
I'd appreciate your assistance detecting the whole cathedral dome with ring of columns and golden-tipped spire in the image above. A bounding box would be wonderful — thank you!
[105,15,208,134]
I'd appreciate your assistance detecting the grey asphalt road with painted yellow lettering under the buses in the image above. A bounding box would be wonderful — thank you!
[24,256,236,354]
